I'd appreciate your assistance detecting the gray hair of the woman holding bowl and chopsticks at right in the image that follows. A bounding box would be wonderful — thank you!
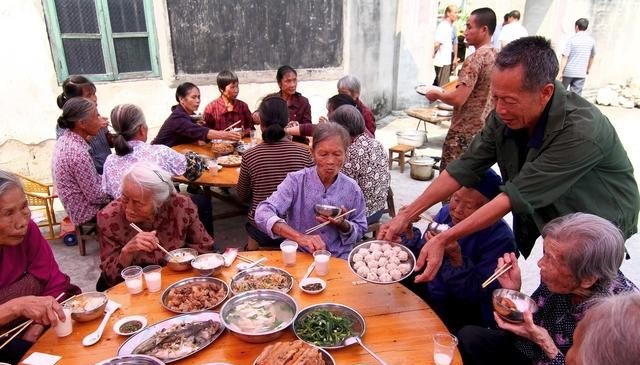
[542,213,624,291]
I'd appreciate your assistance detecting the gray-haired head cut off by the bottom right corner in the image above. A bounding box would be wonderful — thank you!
[574,293,640,365]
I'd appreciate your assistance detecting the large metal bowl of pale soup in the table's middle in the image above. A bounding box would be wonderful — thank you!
[220,290,298,343]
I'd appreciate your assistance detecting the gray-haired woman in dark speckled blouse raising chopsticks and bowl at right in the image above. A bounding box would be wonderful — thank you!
[458,213,638,365]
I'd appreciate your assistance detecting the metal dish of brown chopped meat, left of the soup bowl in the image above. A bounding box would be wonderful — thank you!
[160,277,229,313]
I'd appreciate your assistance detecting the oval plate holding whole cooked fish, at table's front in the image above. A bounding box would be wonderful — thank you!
[118,311,225,364]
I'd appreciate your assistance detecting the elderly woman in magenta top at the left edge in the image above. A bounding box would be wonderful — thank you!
[0,170,80,364]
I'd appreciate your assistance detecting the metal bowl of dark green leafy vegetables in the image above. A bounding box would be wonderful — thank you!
[293,303,365,349]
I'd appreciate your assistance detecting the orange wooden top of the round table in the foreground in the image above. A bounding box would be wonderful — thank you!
[25,251,462,365]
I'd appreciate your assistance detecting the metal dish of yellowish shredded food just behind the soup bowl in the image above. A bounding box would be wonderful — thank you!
[229,266,293,294]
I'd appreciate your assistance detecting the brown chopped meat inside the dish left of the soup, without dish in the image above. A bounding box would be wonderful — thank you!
[165,282,227,312]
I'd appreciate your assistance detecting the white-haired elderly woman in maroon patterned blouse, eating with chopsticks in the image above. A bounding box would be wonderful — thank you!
[97,162,213,290]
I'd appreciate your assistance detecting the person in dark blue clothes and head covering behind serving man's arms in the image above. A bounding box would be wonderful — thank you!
[401,169,516,333]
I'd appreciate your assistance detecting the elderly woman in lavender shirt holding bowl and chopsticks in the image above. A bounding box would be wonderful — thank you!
[255,123,367,259]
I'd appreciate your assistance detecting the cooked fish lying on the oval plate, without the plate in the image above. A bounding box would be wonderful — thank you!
[133,320,220,361]
